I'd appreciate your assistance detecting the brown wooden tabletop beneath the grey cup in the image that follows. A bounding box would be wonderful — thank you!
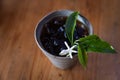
[0,0,120,80]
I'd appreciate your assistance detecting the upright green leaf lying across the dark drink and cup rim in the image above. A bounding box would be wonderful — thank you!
[65,12,79,45]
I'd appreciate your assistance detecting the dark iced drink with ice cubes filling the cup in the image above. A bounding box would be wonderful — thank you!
[40,16,88,56]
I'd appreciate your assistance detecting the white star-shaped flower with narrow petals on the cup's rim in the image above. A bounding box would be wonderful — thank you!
[59,41,77,59]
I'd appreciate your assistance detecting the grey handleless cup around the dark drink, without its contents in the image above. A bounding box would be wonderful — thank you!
[34,10,93,69]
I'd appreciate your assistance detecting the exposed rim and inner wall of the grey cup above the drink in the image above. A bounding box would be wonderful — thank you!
[34,10,93,56]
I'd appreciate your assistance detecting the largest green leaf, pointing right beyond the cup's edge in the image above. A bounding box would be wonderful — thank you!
[79,35,116,53]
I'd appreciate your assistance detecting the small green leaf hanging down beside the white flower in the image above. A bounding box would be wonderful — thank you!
[78,44,88,68]
